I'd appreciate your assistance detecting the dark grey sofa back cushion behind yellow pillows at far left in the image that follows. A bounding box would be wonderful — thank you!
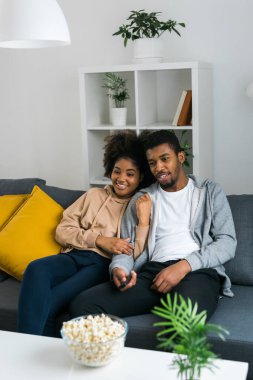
[0,178,46,195]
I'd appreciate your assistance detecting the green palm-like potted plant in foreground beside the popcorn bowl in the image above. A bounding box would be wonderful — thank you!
[152,293,228,380]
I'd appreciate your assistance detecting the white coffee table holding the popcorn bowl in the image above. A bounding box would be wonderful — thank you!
[0,331,248,380]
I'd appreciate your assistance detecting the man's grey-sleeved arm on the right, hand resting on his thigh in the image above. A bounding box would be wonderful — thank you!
[151,185,236,293]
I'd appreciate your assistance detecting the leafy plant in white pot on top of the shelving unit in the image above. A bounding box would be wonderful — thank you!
[113,9,185,62]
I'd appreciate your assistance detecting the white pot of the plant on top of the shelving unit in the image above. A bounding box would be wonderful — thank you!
[133,38,164,63]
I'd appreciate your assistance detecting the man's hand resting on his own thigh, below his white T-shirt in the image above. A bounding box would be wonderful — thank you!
[151,260,191,294]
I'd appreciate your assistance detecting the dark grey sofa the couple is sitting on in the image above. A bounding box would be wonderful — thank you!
[0,179,253,380]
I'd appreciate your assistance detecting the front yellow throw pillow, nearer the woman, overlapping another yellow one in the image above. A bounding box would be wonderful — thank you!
[0,186,63,280]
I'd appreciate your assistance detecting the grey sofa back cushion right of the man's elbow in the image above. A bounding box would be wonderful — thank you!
[225,195,253,285]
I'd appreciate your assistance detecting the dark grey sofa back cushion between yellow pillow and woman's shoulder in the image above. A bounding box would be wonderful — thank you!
[39,185,84,208]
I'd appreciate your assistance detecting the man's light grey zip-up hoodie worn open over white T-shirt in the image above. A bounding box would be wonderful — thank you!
[110,175,236,297]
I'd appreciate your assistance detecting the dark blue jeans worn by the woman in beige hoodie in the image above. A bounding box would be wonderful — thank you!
[18,250,110,336]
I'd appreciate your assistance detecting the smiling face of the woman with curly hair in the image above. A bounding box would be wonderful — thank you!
[111,158,142,198]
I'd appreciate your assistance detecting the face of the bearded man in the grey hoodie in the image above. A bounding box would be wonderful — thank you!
[146,143,188,191]
